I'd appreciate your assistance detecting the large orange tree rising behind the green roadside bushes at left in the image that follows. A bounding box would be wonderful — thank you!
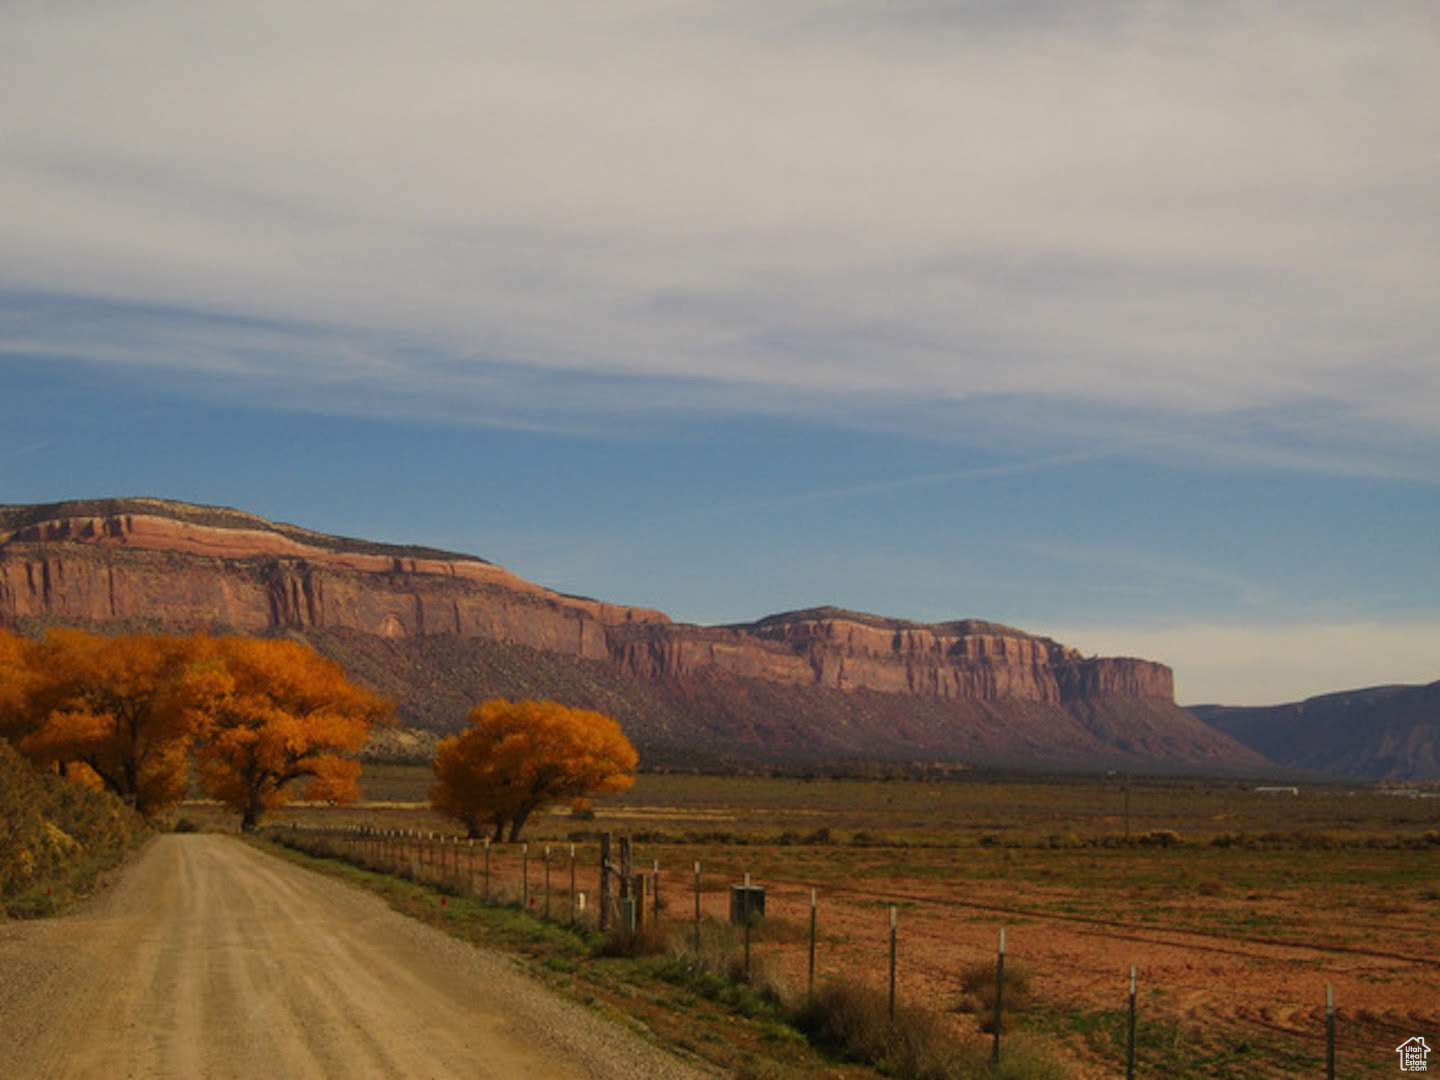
[15,629,203,816]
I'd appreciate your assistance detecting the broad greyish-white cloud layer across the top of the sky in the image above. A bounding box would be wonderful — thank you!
[0,0,1440,457]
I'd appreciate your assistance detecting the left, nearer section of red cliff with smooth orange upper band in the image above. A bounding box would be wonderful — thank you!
[0,500,668,660]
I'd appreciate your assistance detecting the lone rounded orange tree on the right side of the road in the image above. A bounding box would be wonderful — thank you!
[431,698,639,841]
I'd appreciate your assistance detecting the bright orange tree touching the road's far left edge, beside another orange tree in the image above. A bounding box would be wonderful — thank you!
[192,638,390,831]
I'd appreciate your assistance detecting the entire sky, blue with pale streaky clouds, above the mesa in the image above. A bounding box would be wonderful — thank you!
[0,0,1440,703]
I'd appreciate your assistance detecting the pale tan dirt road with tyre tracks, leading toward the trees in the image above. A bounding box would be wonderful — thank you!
[0,835,711,1080]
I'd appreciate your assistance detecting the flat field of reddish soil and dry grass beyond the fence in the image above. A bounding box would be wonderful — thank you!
[186,768,1440,1077]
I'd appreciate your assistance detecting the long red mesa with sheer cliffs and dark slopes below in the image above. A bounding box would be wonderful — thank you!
[0,498,1264,769]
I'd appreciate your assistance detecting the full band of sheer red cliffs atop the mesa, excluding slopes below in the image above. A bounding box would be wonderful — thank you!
[0,500,1174,720]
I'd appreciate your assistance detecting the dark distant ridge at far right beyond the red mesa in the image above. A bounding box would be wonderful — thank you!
[1189,681,1440,780]
